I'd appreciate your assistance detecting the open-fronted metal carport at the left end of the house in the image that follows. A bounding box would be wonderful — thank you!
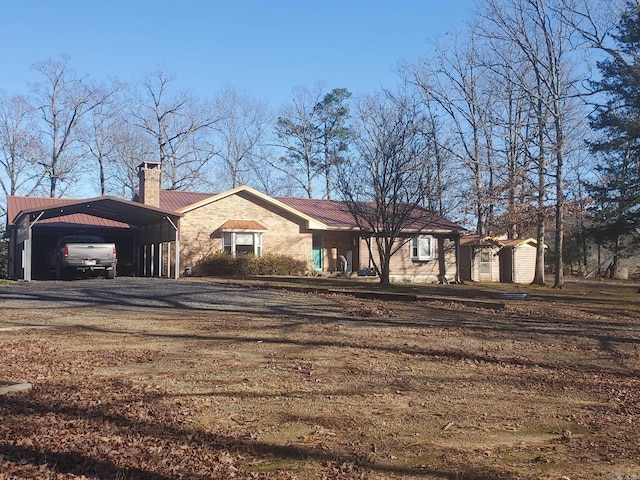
[7,197,182,281]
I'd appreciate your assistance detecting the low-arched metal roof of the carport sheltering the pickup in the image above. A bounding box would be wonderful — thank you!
[8,197,182,227]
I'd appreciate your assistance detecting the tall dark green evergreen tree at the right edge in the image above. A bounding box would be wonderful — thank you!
[588,0,640,274]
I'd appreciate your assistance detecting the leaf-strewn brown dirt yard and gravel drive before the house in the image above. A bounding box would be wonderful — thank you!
[0,278,640,480]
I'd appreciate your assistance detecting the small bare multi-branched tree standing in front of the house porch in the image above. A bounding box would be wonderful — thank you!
[338,91,428,284]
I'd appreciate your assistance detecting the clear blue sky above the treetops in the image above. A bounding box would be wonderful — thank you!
[0,0,477,107]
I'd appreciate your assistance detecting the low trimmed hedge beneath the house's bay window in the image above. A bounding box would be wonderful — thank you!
[198,252,307,277]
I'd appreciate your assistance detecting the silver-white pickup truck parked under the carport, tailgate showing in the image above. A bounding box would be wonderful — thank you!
[47,235,117,280]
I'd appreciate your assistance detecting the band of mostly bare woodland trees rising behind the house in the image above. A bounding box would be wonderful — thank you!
[0,0,640,287]
